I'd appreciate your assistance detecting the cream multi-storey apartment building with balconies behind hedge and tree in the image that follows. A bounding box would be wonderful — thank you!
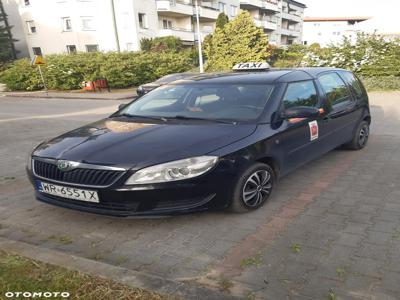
[3,0,305,56]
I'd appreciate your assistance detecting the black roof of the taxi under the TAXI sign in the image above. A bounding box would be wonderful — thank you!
[173,67,344,84]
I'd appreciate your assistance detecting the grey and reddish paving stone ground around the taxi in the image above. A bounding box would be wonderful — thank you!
[0,92,400,299]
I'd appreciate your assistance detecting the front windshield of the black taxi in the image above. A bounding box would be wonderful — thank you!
[117,83,273,122]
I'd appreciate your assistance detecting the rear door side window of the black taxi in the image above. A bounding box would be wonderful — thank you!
[319,73,351,106]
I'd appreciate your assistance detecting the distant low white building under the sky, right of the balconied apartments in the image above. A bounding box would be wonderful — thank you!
[303,17,369,47]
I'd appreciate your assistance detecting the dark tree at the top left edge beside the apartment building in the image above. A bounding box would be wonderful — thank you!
[0,0,17,62]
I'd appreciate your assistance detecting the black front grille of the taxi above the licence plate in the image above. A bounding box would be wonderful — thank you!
[33,159,124,187]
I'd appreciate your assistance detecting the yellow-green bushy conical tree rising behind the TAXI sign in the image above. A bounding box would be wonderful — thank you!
[205,11,270,71]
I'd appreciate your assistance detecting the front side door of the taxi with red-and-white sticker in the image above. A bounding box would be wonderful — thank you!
[278,80,322,175]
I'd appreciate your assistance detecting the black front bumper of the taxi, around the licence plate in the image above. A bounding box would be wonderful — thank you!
[28,164,235,217]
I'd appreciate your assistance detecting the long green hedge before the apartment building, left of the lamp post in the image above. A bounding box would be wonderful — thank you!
[0,51,194,91]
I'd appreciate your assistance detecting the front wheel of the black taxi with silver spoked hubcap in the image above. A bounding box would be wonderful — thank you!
[230,163,275,213]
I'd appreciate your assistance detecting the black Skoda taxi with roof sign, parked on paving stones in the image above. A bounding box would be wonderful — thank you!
[28,64,371,216]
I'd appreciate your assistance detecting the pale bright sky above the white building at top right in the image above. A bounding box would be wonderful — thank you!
[298,0,400,33]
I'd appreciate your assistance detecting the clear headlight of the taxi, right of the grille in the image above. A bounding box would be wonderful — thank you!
[125,156,218,185]
